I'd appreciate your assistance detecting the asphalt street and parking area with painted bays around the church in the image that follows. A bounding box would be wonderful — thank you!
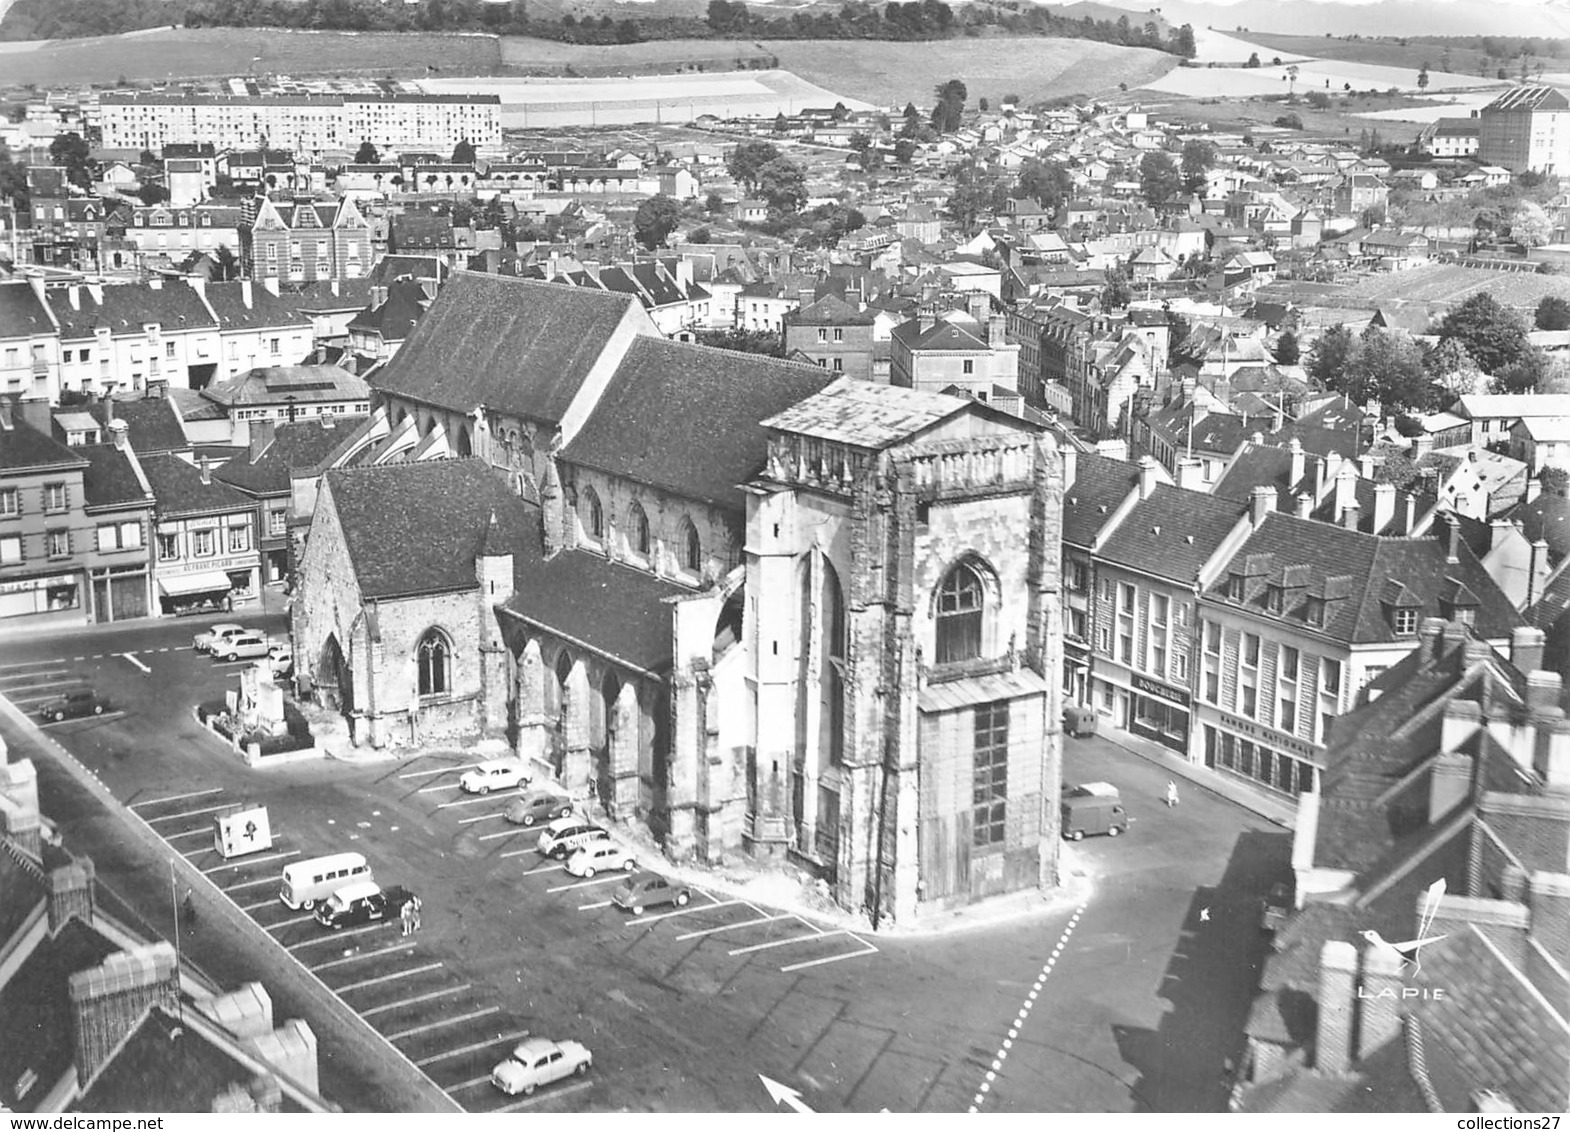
[0,615,1289,1112]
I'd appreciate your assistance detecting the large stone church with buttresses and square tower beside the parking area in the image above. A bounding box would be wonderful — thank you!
[292,273,1063,923]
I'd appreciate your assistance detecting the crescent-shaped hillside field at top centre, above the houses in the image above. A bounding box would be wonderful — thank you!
[763,36,1178,107]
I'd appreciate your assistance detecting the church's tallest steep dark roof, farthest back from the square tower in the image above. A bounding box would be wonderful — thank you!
[372,272,634,424]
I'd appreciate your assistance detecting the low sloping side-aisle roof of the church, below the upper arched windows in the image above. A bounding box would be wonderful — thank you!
[502,550,691,672]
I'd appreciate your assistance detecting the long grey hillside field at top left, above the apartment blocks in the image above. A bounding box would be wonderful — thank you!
[0,28,501,86]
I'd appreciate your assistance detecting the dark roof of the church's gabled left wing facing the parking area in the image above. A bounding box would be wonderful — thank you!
[321,458,542,600]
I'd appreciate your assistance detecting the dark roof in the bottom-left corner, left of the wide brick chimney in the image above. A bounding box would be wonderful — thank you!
[0,917,119,1112]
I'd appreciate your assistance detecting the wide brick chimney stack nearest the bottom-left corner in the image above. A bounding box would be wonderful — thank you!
[69,940,179,1085]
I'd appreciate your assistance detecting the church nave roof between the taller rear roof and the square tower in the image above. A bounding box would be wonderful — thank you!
[562,338,834,509]
